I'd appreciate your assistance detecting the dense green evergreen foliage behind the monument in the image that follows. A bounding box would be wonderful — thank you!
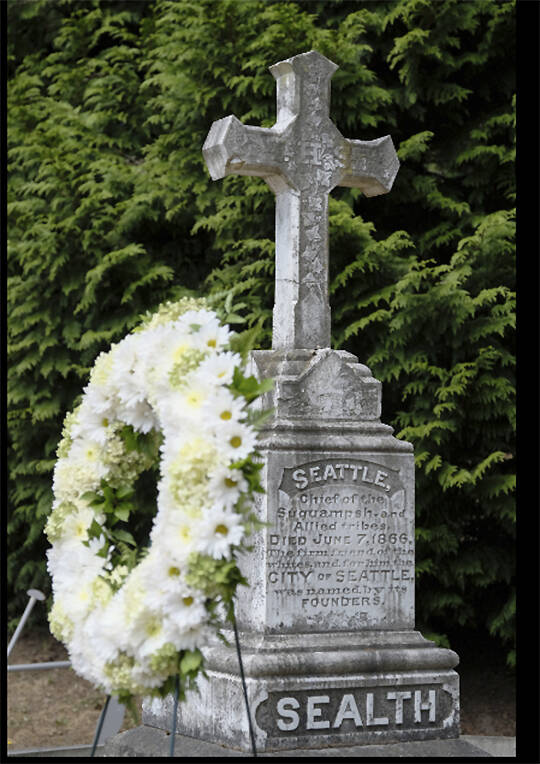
[8,0,515,661]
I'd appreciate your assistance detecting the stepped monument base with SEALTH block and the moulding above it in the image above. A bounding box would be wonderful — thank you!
[143,631,459,752]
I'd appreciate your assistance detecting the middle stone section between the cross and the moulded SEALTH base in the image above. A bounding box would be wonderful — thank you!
[232,350,414,633]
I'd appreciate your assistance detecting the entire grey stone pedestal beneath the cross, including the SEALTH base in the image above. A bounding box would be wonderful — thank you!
[143,349,459,751]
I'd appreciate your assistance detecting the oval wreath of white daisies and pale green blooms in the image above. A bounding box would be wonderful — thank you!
[45,298,267,702]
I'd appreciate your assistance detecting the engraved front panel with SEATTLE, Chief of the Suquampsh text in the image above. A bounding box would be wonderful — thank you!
[267,456,414,631]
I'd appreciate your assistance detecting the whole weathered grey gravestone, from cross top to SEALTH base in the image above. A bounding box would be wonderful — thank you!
[143,51,459,752]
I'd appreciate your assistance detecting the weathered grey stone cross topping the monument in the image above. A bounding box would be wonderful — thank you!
[203,50,399,350]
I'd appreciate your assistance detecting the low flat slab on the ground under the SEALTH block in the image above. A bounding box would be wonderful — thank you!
[99,726,492,759]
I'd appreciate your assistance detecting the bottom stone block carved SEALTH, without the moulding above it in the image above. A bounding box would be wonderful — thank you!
[143,664,459,751]
